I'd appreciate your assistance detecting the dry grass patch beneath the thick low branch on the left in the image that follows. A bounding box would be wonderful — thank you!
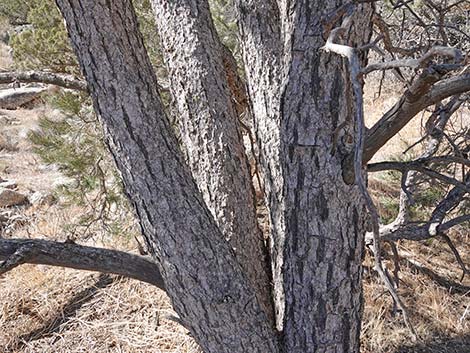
[0,266,198,353]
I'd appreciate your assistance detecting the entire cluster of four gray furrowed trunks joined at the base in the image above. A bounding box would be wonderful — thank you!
[57,0,371,353]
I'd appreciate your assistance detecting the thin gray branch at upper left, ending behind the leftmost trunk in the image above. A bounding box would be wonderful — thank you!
[0,71,88,92]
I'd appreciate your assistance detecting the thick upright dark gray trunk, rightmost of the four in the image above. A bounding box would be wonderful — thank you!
[280,1,371,353]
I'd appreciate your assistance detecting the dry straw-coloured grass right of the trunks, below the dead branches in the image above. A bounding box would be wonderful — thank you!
[362,229,470,353]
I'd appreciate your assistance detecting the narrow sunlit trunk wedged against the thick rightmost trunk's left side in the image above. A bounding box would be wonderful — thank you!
[237,0,284,331]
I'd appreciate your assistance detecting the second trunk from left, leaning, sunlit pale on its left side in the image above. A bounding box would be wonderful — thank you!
[152,0,273,320]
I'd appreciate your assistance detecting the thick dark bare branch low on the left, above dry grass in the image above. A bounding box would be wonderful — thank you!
[0,238,165,290]
